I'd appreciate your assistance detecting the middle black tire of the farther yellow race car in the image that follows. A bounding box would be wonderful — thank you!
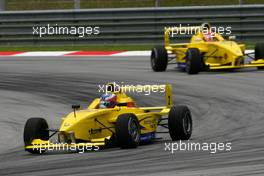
[185,48,203,75]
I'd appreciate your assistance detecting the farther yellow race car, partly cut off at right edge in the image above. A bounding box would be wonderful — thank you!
[151,23,264,74]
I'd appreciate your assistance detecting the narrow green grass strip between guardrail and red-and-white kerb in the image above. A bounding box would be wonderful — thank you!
[0,45,153,51]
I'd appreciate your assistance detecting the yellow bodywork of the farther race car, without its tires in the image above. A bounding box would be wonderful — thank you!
[164,24,264,69]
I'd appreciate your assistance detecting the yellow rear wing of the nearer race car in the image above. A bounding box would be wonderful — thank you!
[106,82,173,108]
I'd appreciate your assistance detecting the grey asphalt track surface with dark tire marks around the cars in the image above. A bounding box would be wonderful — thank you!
[0,57,264,175]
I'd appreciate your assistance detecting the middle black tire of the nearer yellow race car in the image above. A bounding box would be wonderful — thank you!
[115,114,140,148]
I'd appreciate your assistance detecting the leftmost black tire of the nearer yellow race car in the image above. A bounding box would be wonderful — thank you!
[24,117,49,154]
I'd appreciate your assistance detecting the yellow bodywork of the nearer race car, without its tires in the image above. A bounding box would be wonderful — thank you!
[25,84,173,149]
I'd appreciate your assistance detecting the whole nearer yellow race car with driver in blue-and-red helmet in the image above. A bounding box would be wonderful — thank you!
[24,83,192,154]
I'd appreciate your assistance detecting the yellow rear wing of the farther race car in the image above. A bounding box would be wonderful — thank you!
[164,23,211,47]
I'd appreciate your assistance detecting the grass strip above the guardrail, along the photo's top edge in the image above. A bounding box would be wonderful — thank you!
[6,0,264,10]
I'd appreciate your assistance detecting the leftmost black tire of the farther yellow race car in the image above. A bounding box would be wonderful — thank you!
[150,46,168,72]
